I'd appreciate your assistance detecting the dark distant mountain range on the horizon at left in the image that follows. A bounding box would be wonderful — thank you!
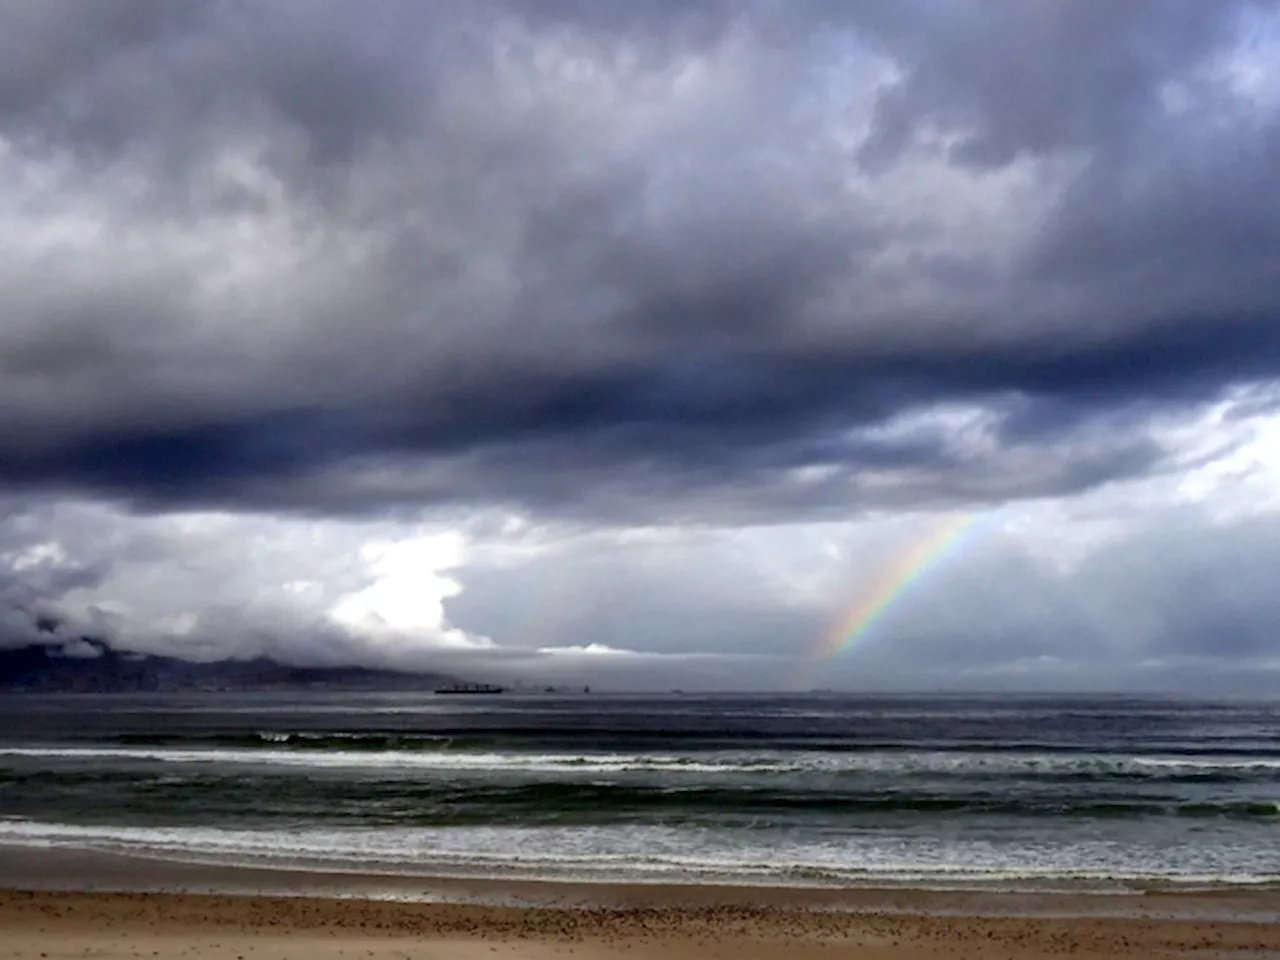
[0,637,458,694]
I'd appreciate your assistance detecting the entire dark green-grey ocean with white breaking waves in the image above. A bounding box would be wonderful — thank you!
[0,694,1280,891]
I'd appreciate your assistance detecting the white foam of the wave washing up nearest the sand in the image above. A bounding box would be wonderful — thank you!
[0,819,1280,888]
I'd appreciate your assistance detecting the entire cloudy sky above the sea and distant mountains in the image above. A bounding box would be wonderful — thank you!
[0,0,1280,694]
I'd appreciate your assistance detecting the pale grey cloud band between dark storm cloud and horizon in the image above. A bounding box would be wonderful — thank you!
[0,483,1280,692]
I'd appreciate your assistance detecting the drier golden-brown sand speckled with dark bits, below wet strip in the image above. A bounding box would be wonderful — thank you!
[0,890,1280,960]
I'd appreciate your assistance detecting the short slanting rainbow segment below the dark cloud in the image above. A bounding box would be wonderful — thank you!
[809,513,982,662]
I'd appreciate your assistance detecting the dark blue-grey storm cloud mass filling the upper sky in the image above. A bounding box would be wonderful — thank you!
[0,0,1280,517]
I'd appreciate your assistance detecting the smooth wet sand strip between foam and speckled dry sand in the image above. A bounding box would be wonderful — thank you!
[0,844,1280,928]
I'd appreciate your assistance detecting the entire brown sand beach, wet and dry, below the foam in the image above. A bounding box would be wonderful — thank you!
[0,846,1280,960]
